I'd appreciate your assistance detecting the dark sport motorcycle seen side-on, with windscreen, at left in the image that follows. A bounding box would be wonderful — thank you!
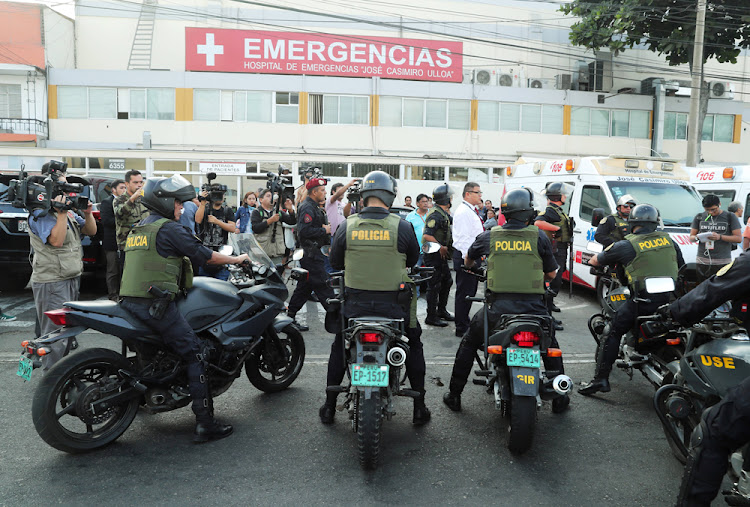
[18,234,307,453]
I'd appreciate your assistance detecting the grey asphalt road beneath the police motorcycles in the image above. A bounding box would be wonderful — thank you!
[0,282,721,506]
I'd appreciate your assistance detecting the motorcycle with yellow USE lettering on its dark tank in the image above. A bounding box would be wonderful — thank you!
[654,304,750,505]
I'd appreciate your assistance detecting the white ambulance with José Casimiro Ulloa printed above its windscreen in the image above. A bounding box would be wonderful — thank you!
[505,156,703,296]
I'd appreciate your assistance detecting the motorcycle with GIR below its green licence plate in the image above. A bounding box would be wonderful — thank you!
[465,267,573,454]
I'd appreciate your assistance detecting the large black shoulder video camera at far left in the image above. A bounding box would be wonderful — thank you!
[8,160,89,216]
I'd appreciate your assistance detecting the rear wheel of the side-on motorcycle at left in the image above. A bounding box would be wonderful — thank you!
[31,349,139,454]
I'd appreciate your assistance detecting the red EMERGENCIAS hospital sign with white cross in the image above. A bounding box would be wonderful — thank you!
[185,27,463,83]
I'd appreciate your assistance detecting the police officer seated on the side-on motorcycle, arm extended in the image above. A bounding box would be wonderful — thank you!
[120,175,248,443]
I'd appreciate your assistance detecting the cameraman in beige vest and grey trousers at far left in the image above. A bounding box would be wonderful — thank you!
[29,163,96,370]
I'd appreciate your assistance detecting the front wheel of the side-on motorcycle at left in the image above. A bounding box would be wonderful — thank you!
[245,324,305,393]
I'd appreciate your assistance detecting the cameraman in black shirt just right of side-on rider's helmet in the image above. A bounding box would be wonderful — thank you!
[195,188,236,281]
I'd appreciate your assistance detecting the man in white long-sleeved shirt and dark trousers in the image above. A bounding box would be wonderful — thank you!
[453,181,484,336]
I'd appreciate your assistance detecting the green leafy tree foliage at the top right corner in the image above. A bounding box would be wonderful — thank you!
[560,0,750,65]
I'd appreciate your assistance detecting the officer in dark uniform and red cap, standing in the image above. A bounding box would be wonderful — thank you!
[287,178,333,331]
